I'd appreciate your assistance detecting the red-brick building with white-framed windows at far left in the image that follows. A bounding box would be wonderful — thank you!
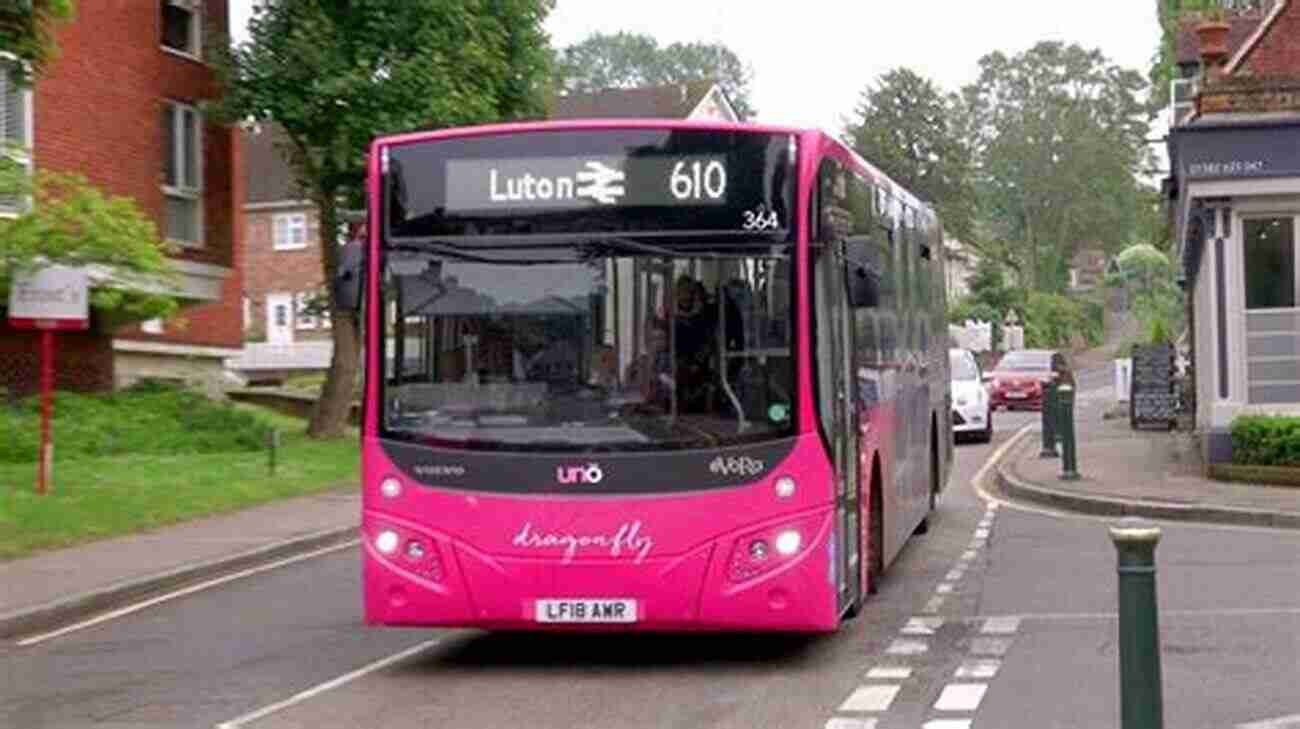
[0,0,243,392]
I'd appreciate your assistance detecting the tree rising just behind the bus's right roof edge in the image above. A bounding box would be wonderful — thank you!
[844,68,975,240]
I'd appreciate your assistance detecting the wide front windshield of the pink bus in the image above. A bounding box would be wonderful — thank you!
[380,238,794,451]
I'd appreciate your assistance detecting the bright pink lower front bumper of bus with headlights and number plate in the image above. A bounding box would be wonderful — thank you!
[363,508,839,632]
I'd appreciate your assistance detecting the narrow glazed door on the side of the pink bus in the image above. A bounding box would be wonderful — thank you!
[814,239,862,611]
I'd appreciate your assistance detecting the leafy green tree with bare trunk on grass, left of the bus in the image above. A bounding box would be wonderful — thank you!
[217,0,553,437]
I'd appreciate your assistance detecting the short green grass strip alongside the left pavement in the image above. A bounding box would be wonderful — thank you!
[0,404,360,560]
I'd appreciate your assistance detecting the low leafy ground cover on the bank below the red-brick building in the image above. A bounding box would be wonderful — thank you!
[0,385,269,463]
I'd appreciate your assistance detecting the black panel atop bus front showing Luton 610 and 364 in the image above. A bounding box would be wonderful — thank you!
[386,130,794,239]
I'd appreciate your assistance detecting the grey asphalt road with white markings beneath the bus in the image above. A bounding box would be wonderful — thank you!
[0,384,1300,729]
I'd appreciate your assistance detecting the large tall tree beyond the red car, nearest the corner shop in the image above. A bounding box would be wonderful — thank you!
[962,42,1149,291]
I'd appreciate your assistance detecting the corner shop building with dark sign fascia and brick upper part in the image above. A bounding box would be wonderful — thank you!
[1166,0,1300,463]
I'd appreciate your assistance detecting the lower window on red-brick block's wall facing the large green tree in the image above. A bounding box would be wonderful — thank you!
[163,101,203,247]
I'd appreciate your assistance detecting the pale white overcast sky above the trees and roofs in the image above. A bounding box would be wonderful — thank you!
[230,0,1175,170]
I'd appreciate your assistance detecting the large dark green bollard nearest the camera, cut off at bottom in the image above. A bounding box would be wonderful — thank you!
[1110,517,1165,729]
